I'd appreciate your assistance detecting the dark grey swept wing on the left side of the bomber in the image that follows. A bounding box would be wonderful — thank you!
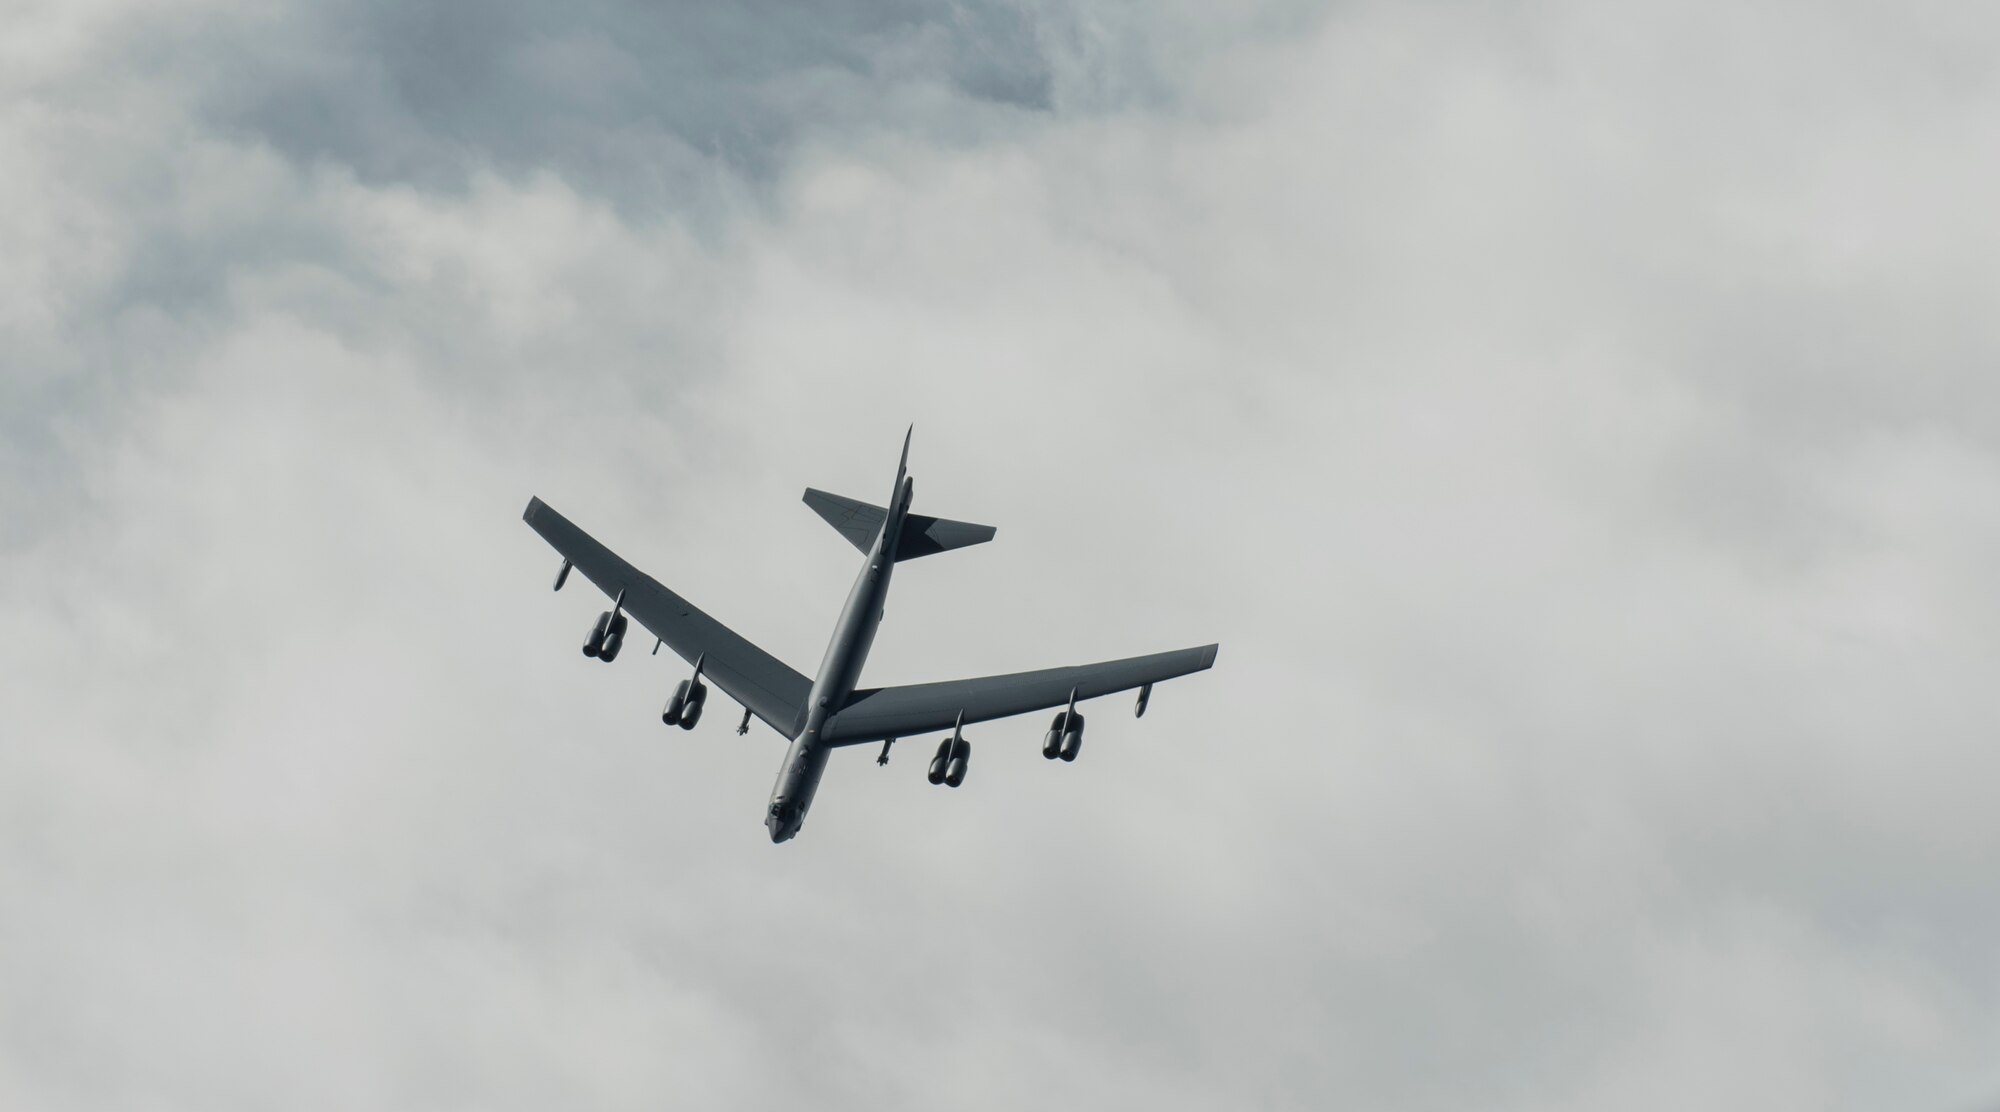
[522,498,812,738]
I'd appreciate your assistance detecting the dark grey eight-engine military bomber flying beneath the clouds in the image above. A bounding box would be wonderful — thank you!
[522,426,1216,842]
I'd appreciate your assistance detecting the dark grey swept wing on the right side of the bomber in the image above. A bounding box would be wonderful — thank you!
[822,644,1216,744]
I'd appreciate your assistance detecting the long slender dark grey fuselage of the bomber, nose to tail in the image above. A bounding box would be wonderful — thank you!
[764,472,914,842]
